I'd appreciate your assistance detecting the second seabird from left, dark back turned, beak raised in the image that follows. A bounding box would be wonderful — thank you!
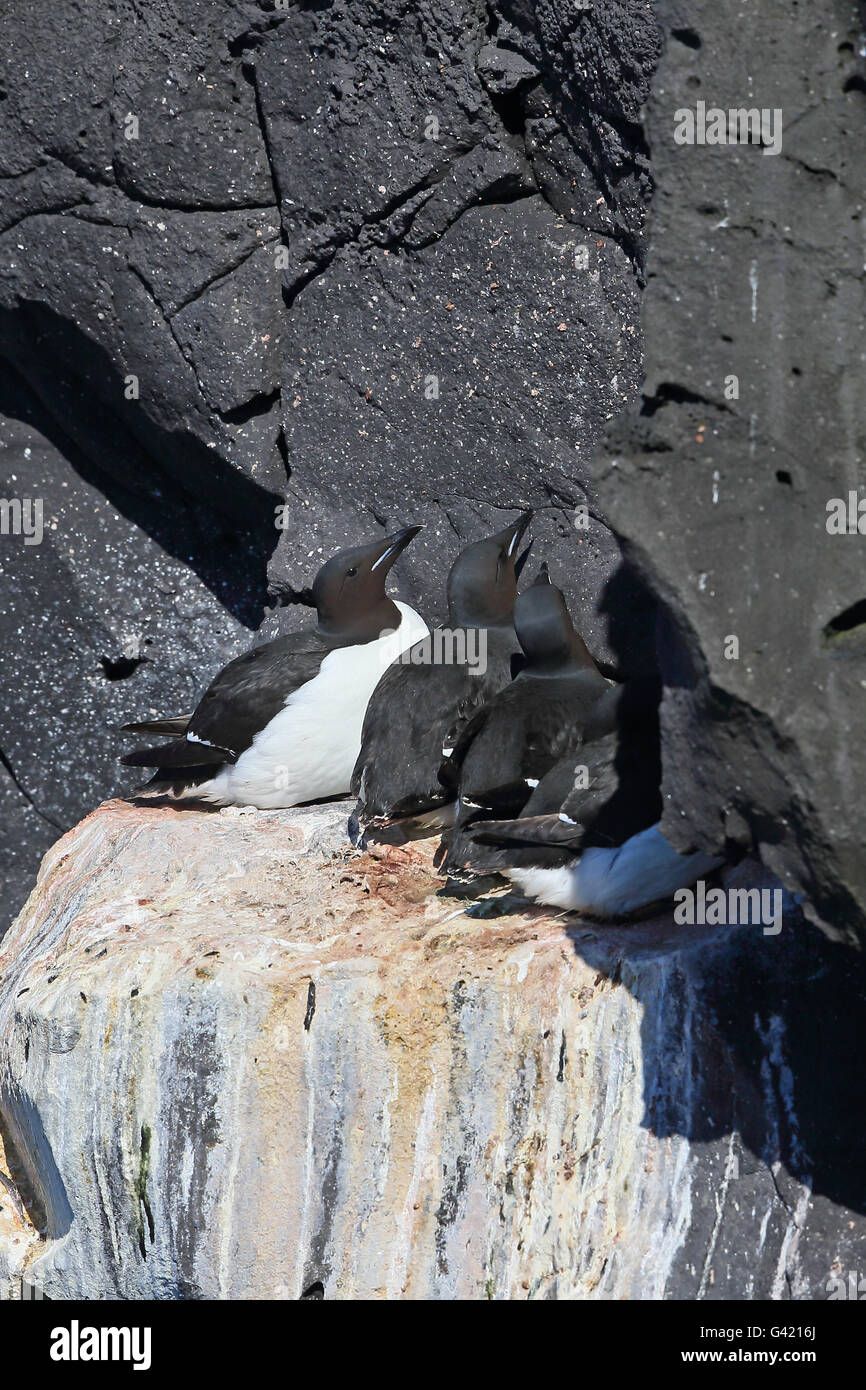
[349,512,532,842]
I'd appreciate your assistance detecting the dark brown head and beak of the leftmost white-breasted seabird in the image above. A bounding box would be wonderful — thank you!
[313,525,421,646]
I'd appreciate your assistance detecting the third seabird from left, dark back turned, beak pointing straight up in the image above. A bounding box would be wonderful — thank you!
[441,566,609,873]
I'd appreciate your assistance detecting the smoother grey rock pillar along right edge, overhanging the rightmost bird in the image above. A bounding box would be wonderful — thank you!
[599,0,866,941]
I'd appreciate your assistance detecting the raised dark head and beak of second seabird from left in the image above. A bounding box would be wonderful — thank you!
[448,512,532,627]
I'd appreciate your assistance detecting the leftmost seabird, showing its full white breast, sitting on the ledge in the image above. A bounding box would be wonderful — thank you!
[122,525,428,808]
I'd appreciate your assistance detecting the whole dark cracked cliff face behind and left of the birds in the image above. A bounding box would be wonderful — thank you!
[0,0,659,930]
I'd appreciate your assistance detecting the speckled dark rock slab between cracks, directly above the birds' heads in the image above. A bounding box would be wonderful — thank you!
[265,196,652,644]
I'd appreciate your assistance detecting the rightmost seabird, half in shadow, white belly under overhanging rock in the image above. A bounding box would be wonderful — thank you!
[464,680,721,917]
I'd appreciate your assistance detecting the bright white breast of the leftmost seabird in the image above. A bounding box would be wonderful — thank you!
[197,603,428,808]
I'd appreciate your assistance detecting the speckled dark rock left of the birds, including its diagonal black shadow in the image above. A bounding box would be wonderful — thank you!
[0,366,267,924]
